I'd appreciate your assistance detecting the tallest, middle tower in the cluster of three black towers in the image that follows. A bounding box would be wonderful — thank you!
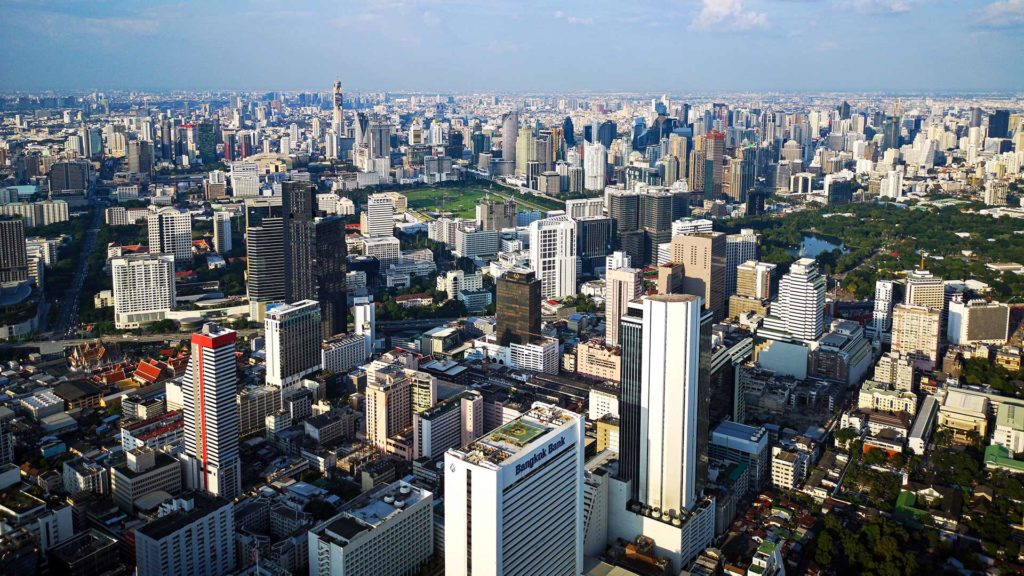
[281,181,316,302]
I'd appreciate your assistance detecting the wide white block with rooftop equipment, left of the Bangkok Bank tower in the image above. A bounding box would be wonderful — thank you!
[308,481,434,576]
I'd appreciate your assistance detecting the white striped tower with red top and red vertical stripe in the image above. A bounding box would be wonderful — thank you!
[181,324,242,499]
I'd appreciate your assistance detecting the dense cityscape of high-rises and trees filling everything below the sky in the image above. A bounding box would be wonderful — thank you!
[0,6,1024,576]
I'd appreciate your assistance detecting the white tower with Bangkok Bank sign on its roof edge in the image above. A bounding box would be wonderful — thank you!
[444,402,584,576]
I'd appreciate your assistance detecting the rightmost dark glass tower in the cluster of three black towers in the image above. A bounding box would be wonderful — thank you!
[314,216,348,340]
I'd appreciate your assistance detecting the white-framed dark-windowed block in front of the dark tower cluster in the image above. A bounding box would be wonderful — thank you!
[264,300,323,388]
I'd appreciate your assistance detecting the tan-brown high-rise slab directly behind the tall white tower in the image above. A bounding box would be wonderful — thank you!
[672,232,726,320]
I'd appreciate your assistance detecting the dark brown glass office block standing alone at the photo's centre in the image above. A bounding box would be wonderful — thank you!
[495,271,541,346]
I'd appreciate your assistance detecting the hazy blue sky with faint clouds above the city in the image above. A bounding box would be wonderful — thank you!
[0,0,1024,92]
